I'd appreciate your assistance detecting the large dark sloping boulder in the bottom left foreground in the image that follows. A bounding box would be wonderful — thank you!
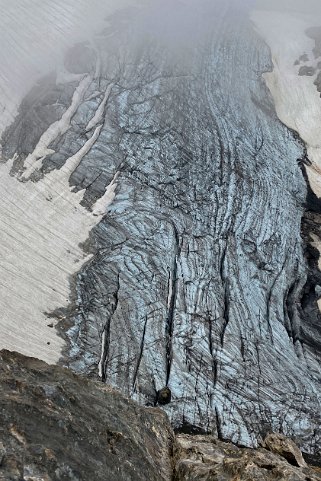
[0,351,173,481]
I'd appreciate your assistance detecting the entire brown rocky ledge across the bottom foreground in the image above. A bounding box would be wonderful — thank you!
[0,351,321,481]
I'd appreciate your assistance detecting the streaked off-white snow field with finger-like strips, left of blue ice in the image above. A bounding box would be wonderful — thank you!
[0,76,119,363]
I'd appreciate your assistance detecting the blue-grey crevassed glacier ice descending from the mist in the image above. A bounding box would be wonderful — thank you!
[3,2,321,452]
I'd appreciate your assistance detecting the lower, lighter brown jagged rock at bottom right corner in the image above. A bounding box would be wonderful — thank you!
[174,434,321,481]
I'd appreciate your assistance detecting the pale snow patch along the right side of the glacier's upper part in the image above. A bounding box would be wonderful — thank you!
[252,11,321,197]
